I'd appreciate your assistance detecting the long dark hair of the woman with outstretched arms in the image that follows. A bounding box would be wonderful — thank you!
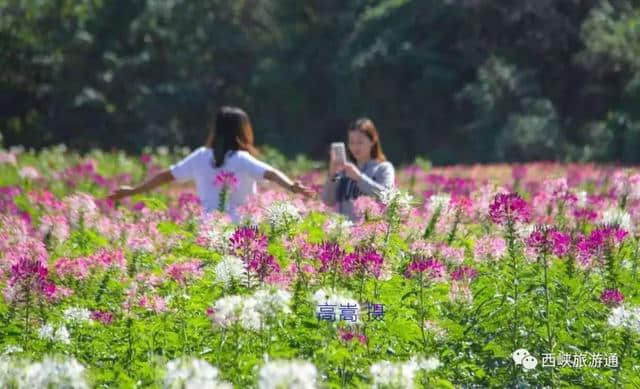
[205,106,258,168]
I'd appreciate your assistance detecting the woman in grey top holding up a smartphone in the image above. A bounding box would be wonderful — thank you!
[322,118,395,220]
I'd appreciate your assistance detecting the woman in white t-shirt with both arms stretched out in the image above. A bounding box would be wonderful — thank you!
[109,107,313,222]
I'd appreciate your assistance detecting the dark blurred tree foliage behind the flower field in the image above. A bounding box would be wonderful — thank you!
[0,0,640,164]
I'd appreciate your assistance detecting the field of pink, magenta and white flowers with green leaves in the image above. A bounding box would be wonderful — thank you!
[0,147,640,388]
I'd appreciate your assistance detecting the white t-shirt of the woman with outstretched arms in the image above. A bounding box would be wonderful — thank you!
[170,146,271,221]
